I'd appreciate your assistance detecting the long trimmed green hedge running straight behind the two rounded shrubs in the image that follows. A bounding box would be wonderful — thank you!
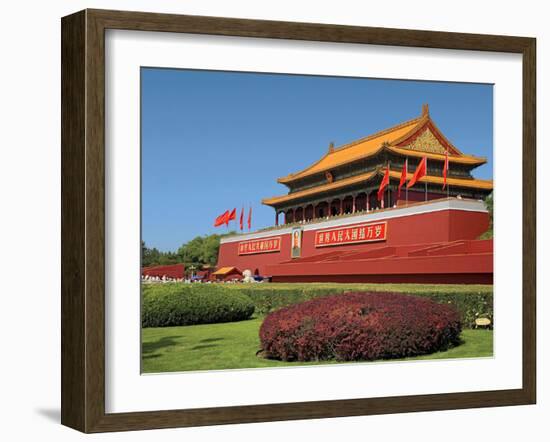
[143,283,493,328]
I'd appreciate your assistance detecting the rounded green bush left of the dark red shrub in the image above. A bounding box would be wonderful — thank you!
[141,284,254,327]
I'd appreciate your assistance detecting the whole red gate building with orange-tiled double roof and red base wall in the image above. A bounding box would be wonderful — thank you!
[218,105,493,283]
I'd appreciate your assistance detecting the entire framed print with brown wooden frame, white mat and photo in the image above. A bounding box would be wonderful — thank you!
[62,10,536,432]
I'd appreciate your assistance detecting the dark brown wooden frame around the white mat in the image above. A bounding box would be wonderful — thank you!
[61,10,536,432]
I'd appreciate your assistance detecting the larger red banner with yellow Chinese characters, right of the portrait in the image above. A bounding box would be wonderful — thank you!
[315,221,388,247]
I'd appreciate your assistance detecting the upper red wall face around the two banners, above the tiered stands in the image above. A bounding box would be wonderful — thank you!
[218,205,489,276]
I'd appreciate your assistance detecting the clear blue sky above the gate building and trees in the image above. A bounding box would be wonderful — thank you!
[141,68,493,251]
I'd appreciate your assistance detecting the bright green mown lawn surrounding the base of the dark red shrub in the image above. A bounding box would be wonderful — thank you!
[142,318,493,373]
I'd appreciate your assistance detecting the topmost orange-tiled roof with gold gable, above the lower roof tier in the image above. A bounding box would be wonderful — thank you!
[277,105,487,184]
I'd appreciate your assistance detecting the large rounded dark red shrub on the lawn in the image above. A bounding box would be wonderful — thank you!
[260,293,462,361]
